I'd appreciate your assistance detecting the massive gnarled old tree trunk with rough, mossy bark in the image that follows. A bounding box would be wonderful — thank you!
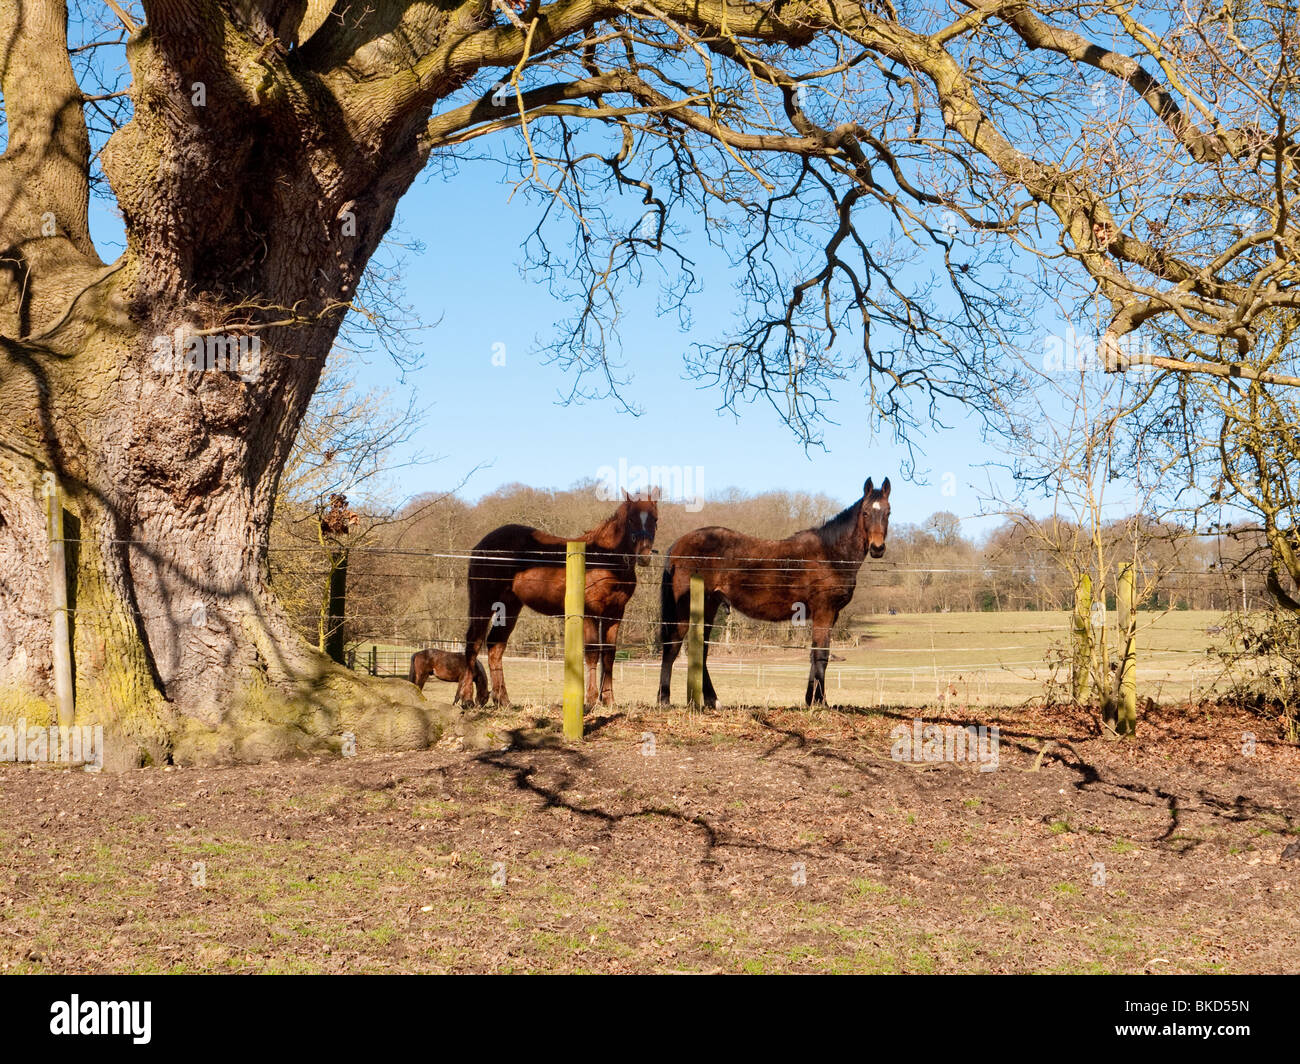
[0,0,462,764]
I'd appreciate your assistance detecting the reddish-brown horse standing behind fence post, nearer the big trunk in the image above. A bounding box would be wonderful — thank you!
[456,489,659,706]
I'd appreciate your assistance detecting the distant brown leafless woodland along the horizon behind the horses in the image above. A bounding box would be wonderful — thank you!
[270,484,1266,653]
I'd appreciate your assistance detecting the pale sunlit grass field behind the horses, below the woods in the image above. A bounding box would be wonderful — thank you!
[356,610,1230,706]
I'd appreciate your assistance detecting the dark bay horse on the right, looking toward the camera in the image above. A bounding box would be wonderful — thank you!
[659,477,889,709]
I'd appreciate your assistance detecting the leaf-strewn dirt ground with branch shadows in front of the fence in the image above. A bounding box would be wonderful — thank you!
[0,708,1300,973]
